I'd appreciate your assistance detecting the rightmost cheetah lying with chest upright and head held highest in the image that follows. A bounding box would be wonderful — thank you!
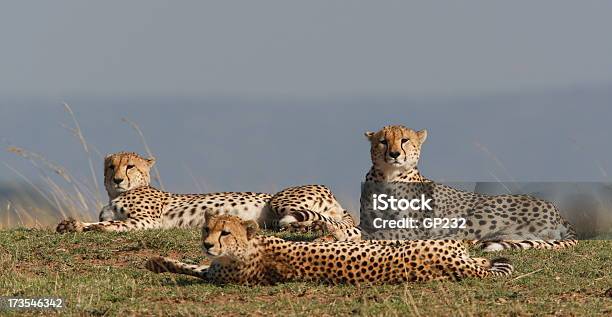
[316,126,577,251]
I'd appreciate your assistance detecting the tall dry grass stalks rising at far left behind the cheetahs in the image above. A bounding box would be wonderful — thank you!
[0,103,166,229]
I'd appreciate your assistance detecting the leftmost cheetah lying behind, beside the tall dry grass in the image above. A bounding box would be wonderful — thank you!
[56,152,354,233]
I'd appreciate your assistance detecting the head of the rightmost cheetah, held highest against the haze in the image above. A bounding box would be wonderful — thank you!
[365,125,427,169]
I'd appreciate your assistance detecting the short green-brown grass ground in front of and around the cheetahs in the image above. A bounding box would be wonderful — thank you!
[0,229,612,316]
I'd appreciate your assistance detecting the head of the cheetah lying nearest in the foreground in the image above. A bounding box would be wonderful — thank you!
[202,215,259,257]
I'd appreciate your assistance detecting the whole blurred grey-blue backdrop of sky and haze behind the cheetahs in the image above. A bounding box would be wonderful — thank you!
[0,0,612,232]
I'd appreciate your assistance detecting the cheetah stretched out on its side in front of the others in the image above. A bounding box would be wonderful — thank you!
[145,215,513,284]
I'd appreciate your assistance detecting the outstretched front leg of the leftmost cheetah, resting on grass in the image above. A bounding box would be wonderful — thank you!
[55,217,161,233]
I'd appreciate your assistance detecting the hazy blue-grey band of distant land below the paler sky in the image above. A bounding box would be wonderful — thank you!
[0,86,612,204]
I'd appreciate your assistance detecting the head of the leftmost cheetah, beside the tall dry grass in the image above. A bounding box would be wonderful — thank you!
[104,152,155,199]
